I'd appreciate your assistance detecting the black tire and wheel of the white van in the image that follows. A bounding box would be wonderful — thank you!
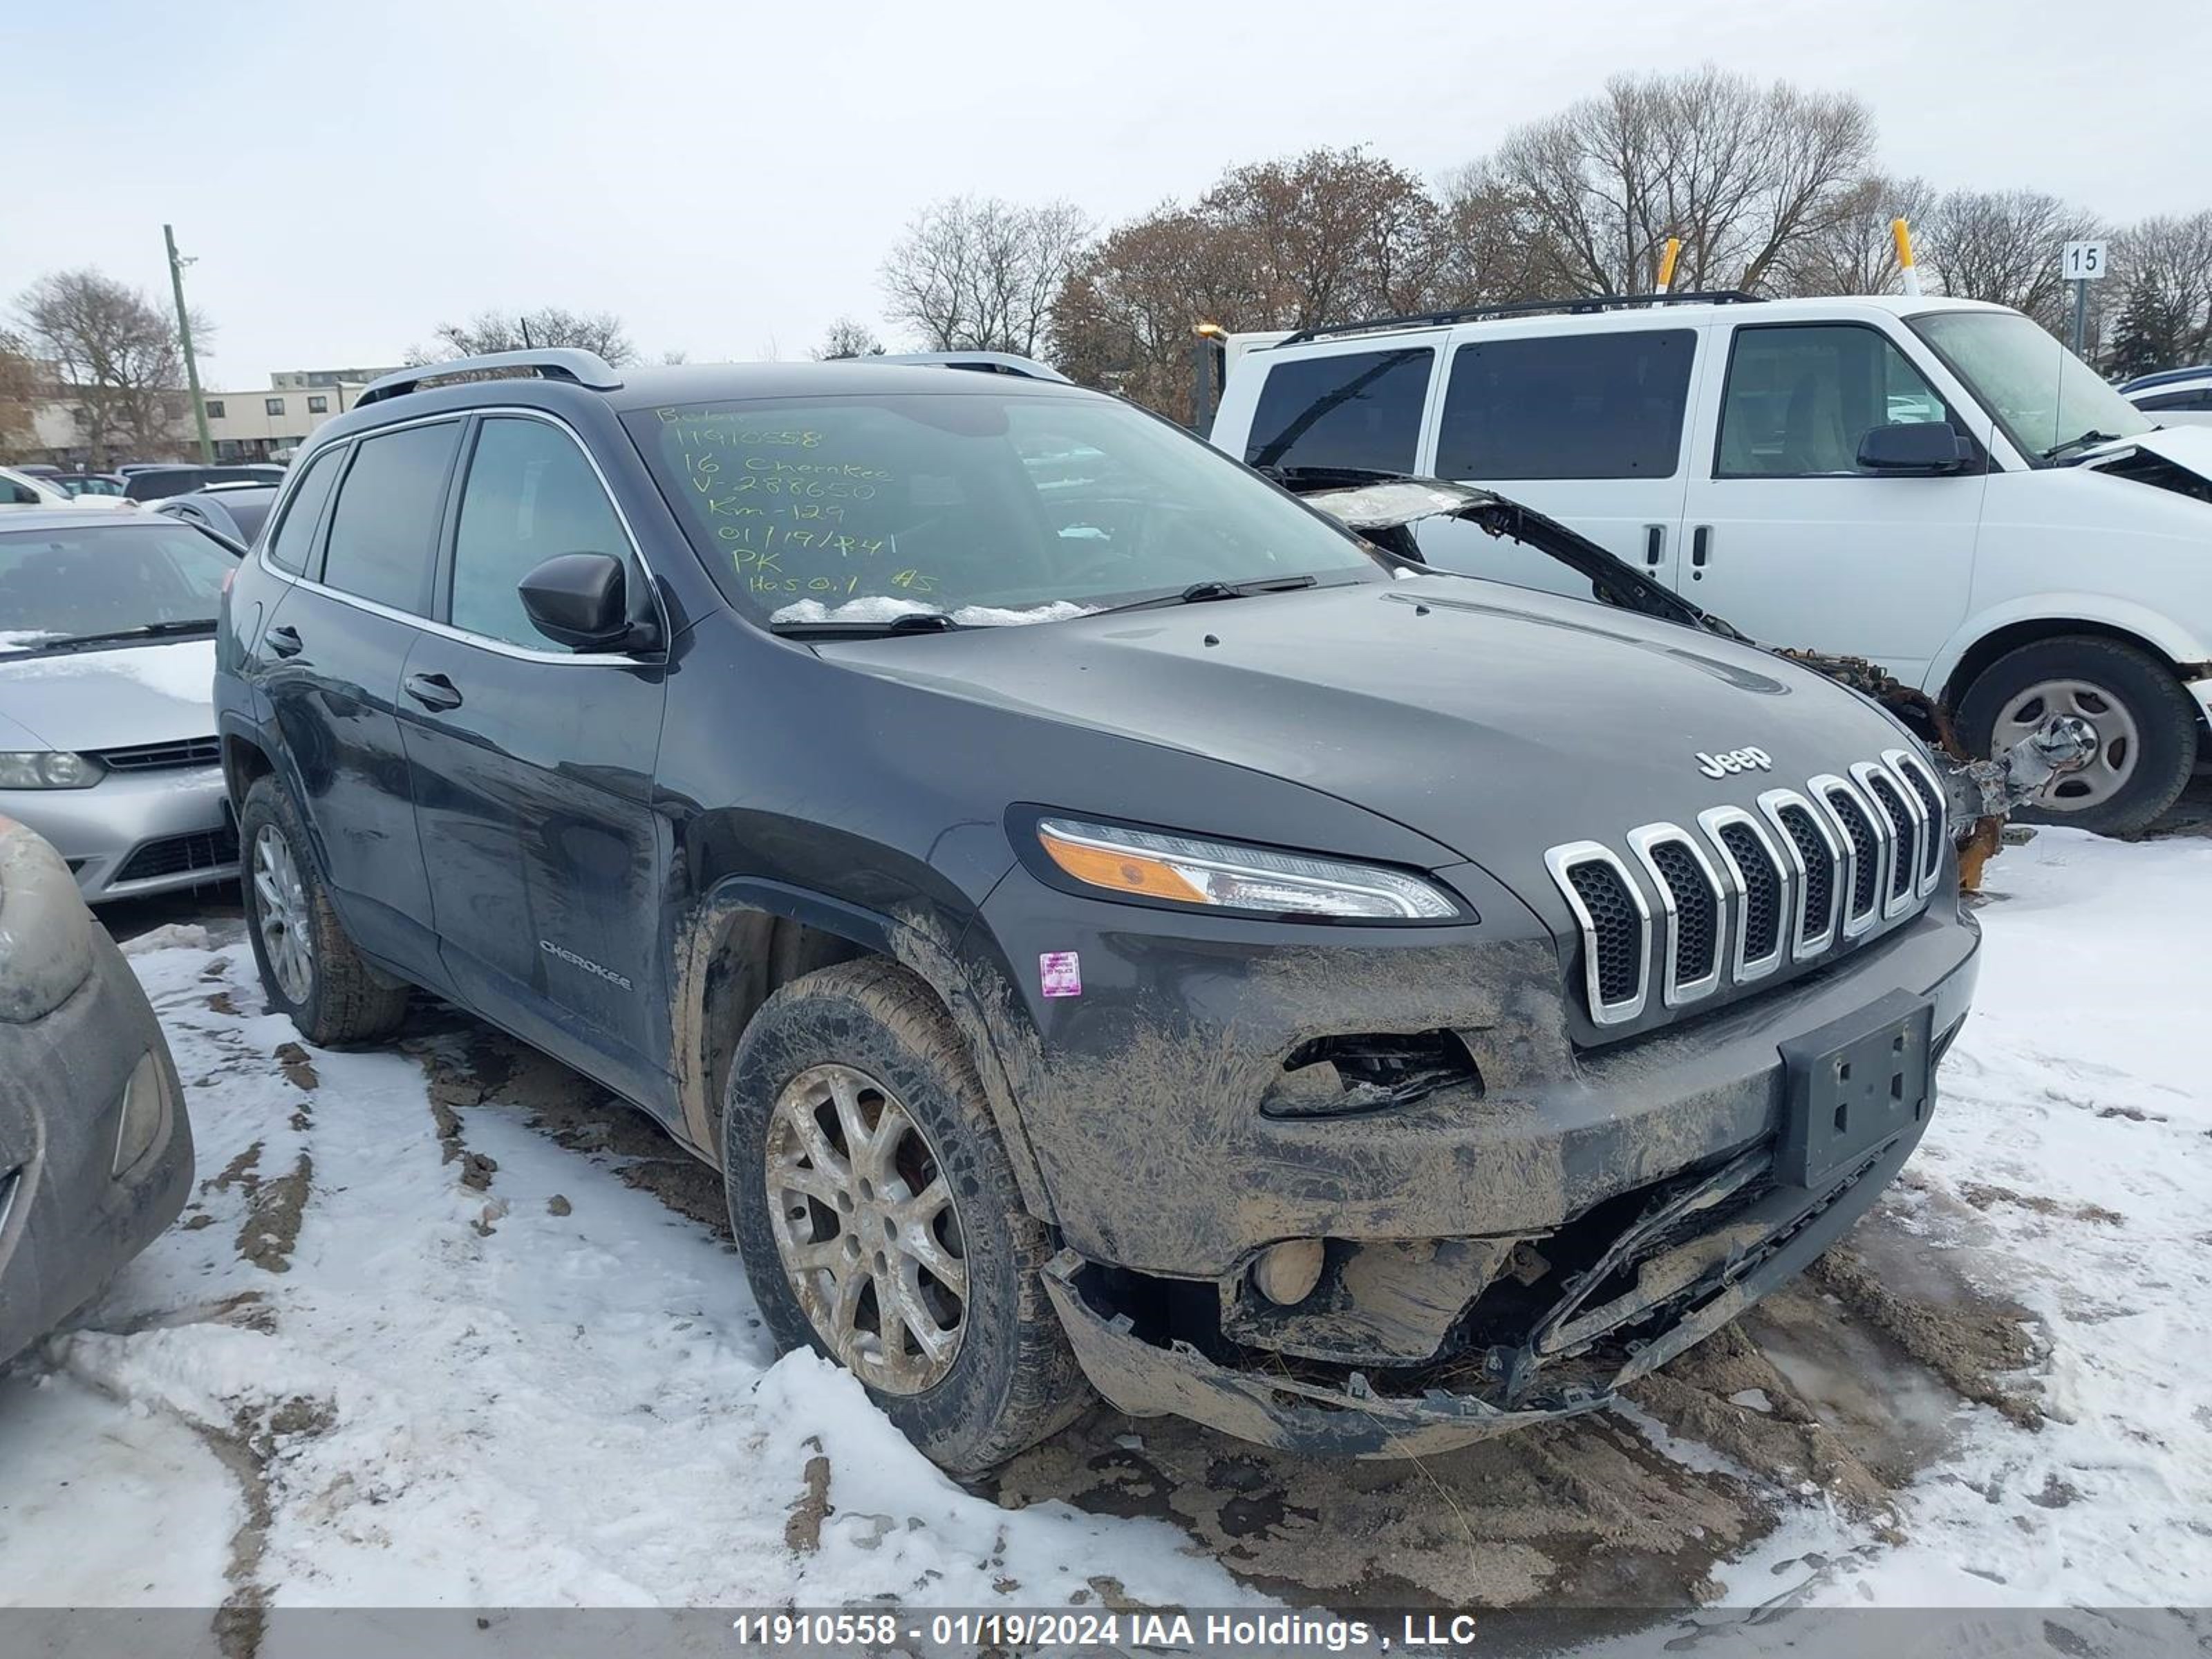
[1958,635,2197,836]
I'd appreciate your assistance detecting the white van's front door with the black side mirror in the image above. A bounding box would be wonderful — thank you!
[1674,323,1989,686]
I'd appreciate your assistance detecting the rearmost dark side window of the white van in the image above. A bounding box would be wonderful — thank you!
[1246,345,1436,474]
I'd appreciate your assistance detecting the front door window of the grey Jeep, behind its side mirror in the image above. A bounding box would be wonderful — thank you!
[449,418,639,650]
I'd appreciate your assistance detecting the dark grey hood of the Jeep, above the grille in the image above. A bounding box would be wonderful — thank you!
[816,575,1909,876]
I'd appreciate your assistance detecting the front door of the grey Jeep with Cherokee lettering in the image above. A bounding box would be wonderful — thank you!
[400,411,668,1106]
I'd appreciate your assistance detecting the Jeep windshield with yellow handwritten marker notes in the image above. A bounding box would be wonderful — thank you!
[628,391,1387,626]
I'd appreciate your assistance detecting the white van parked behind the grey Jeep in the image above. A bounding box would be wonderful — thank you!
[1212,297,2212,832]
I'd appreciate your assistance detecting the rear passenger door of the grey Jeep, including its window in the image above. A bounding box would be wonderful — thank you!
[254,420,462,984]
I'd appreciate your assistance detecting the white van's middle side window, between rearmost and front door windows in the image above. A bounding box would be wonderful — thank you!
[1436,328,1696,480]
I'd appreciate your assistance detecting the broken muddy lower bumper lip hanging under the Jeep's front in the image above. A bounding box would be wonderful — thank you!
[1044,1121,1927,1458]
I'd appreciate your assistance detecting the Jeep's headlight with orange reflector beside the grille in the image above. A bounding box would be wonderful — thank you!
[1038,818,1464,922]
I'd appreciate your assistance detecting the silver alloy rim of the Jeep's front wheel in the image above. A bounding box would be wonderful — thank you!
[765,1066,969,1394]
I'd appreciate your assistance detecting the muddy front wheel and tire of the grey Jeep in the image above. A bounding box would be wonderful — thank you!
[723,960,1091,1473]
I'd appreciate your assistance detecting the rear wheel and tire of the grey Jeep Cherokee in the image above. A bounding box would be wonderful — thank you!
[239,776,407,1049]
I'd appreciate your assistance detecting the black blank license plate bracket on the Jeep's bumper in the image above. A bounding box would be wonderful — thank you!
[1774,991,1936,1188]
